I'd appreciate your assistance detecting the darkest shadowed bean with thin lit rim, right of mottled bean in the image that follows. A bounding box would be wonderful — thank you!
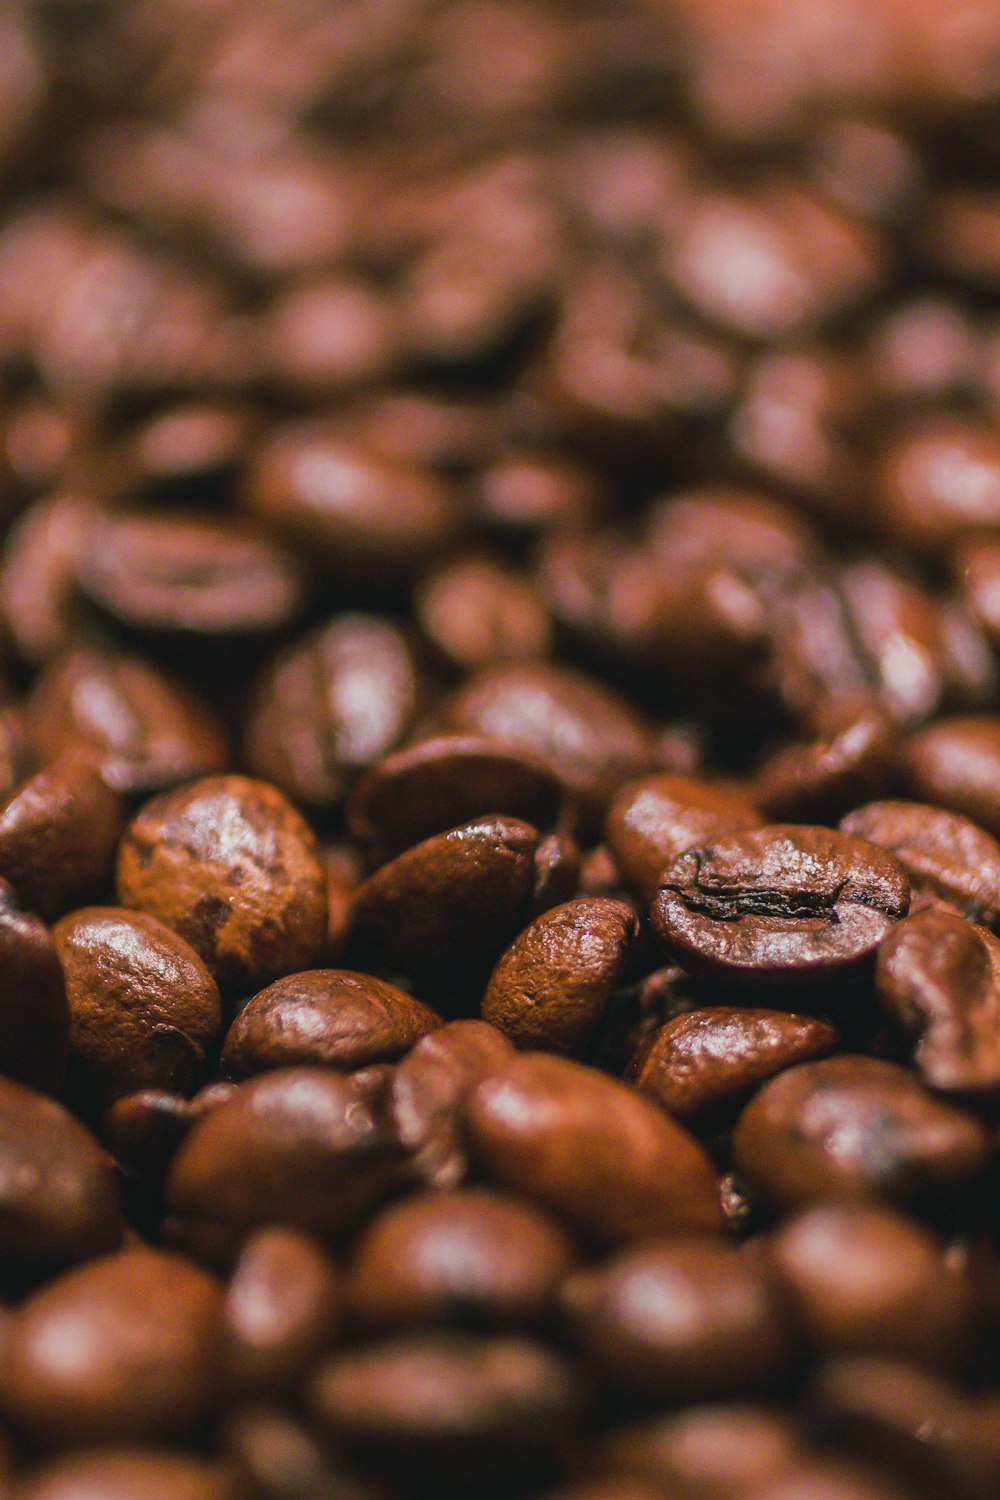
[346,735,559,860]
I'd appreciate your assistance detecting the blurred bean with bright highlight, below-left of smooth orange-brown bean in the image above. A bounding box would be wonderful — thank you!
[345,1188,574,1331]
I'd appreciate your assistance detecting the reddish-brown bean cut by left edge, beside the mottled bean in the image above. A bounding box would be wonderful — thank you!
[0,759,123,921]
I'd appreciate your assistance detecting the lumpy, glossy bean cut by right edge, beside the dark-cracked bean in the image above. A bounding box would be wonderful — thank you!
[876,908,1000,1095]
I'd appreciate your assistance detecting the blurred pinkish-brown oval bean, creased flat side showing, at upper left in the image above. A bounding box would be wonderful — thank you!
[76,512,304,639]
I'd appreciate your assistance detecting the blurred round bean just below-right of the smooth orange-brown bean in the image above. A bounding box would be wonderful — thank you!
[565,1238,792,1401]
